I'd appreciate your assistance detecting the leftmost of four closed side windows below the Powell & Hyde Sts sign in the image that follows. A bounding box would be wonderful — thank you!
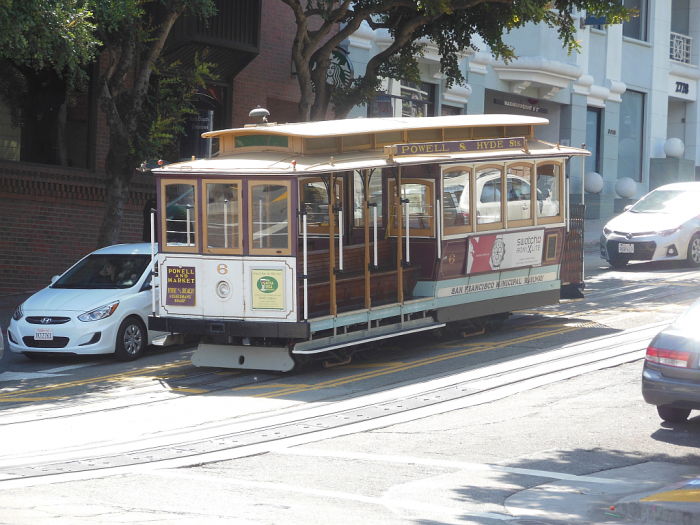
[442,166,474,235]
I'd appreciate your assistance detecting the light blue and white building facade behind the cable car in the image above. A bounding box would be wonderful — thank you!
[346,0,700,217]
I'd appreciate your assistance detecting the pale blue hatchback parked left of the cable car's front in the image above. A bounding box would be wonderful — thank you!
[7,243,164,361]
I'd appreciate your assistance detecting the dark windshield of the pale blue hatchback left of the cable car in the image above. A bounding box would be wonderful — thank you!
[51,254,151,290]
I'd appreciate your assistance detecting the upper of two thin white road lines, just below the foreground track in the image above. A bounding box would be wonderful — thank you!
[280,448,625,485]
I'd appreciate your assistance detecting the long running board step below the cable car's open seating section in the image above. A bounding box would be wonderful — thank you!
[292,317,445,354]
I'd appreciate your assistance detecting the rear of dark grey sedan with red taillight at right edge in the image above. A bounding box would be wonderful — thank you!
[642,300,700,423]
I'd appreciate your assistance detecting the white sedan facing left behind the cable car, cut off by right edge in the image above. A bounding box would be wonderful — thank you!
[600,182,700,268]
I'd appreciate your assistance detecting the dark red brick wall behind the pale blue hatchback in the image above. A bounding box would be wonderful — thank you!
[0,161,155,294]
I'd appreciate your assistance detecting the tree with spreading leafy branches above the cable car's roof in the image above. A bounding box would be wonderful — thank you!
[281,0,630,121]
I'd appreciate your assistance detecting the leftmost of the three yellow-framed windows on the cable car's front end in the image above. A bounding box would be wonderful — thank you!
[161,180,199,252]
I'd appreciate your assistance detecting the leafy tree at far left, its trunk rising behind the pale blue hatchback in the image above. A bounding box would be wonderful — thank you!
[0,0,216,247]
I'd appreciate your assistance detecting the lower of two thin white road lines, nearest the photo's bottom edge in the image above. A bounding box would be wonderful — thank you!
[144,470,516,521]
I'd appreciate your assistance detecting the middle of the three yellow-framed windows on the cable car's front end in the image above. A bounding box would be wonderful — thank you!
[202,180,242,253]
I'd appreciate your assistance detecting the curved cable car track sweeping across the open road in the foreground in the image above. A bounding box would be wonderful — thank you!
[0,323,665,489]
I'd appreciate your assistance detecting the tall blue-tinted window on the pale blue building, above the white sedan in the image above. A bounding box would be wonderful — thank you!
[617,90,644,182]
